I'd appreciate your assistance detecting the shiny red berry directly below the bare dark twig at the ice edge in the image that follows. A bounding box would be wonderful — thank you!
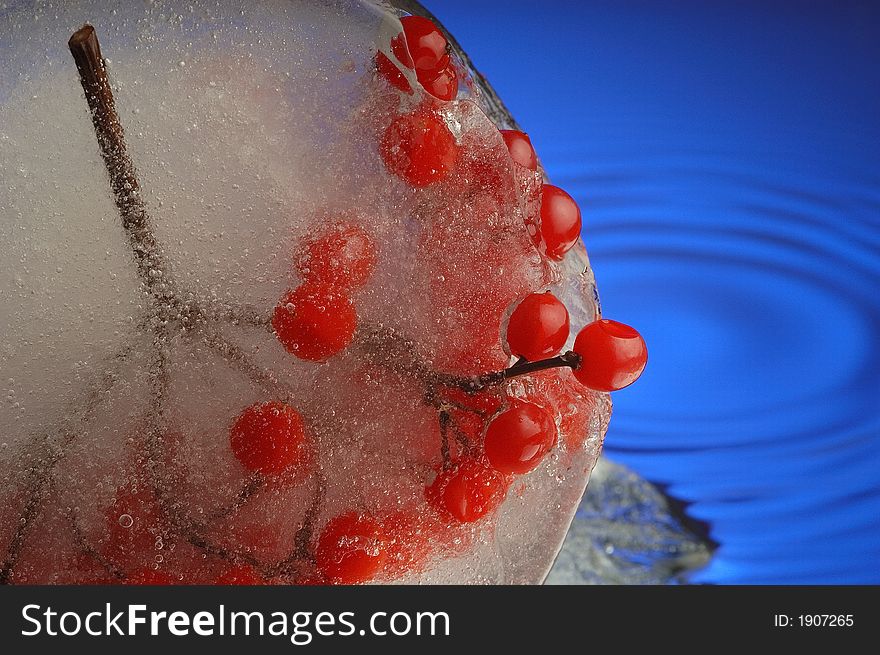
[485,400,557,474]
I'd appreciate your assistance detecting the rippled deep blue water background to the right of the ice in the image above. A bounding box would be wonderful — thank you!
[436,0,880,584]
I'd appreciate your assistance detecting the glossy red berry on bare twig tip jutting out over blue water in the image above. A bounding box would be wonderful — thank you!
[573,318,648,391]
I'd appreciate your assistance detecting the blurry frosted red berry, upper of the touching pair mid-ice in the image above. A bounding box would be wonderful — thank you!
[296,224,376,291]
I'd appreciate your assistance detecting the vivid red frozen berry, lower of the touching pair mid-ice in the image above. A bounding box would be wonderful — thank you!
[272,284,357,362]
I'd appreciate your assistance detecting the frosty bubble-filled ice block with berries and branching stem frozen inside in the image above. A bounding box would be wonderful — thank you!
[0,0,610,583]
